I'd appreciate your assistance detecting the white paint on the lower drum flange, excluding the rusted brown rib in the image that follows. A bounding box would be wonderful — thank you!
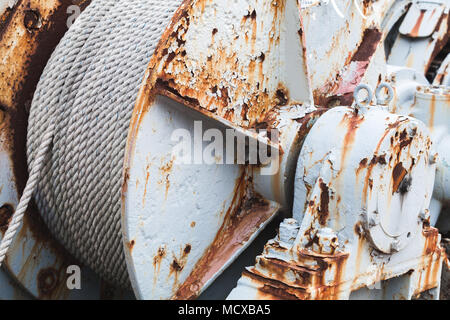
[123,97,278,299]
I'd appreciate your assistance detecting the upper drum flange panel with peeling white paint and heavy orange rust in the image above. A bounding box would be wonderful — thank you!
[142,0,310,128]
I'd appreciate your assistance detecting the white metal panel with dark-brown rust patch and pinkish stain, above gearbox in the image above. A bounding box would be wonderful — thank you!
[301,1,392,107]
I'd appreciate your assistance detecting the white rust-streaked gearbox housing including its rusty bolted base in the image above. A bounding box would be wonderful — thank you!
[228,107,443,299]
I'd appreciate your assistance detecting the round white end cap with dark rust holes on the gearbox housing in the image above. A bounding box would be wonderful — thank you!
[364,117,434,253]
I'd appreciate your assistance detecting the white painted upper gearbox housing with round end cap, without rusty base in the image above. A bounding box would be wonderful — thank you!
[293,107,434,253]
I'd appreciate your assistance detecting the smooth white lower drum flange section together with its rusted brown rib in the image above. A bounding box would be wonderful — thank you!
[122,96,278,299]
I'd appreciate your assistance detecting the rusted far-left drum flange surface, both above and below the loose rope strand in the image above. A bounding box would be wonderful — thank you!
[0,1,81,298]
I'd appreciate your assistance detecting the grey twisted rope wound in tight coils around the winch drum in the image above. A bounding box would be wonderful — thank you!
[27,0,181,287]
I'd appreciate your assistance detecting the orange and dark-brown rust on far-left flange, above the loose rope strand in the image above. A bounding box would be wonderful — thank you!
[0,0,90,193]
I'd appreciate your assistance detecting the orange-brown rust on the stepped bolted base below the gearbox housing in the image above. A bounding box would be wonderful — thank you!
[243,212,444,300]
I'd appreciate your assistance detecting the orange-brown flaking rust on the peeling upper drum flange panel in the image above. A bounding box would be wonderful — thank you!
[137,1,288,128]
